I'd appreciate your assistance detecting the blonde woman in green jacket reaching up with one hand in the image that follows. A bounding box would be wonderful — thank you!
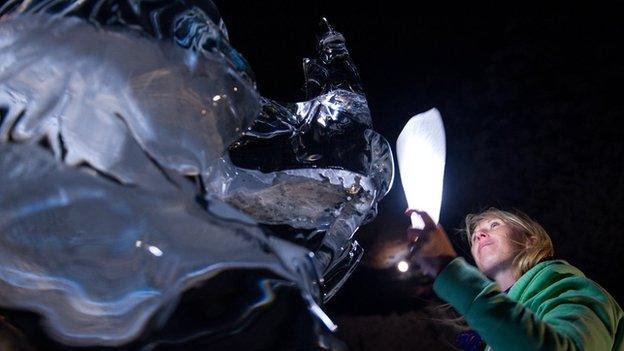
[406,208,624,351]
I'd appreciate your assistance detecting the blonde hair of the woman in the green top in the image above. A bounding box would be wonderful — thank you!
[462,207,555,279]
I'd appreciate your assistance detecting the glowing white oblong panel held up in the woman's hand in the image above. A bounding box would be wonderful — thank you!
[397,108,446,228]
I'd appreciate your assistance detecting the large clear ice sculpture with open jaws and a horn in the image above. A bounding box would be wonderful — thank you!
[0,0,393,346]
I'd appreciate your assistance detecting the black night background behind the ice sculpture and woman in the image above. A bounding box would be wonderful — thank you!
[216,0,624,350]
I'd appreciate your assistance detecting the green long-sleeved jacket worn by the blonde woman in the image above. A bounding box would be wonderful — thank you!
[433,258,624,351]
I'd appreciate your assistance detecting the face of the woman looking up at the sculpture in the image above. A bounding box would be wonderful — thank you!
[470,217,526,278]
